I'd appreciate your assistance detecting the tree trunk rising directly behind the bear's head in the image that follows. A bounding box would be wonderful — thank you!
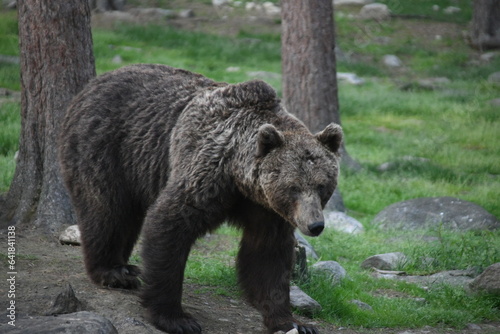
[281,0,361,170]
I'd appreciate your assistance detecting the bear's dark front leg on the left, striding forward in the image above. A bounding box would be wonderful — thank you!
[141,193,205,334]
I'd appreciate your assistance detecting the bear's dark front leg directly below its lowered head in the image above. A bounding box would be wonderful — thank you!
[238,215,319,334]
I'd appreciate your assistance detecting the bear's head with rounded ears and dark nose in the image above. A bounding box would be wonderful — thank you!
[256,123,343,236]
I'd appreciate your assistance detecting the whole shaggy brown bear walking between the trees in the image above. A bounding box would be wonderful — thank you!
[56,65,342,334]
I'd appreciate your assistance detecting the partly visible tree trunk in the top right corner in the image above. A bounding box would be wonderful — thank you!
[471,0,500,50]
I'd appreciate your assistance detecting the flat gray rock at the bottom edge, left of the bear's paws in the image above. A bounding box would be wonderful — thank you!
[10,311,118,334]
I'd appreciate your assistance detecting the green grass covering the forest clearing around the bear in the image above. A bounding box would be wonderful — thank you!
[0,0,500,328]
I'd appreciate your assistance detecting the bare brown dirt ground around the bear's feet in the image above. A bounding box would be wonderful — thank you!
[0,228,500,334]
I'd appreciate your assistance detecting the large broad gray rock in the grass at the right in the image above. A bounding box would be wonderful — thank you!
[372,197,500,230]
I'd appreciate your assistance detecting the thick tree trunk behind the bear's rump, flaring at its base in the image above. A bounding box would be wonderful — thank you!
[0,0,95,232]
